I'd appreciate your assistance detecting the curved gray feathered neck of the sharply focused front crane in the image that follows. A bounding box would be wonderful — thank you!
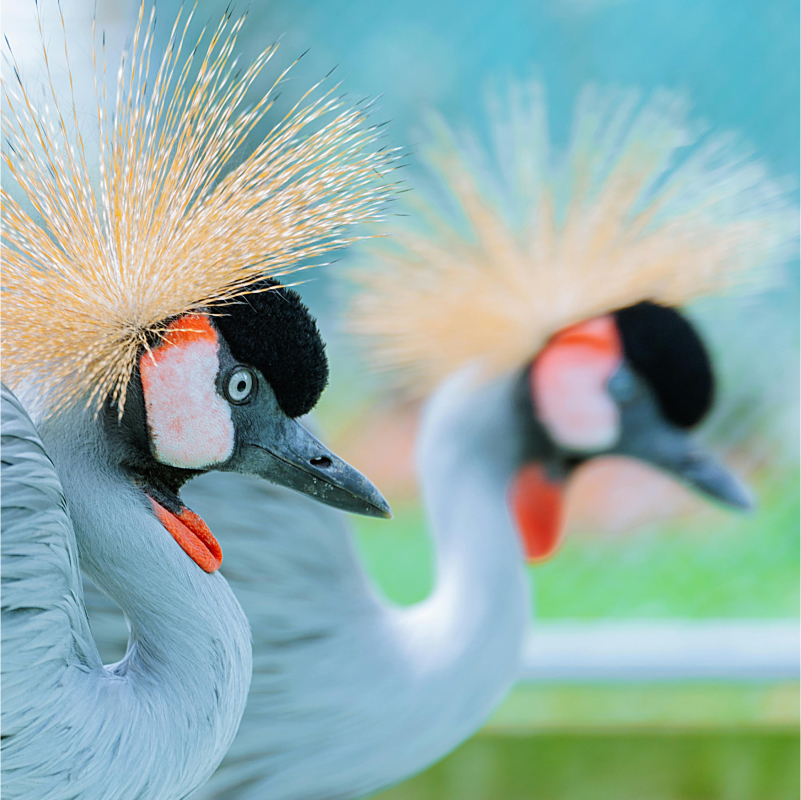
[41,411,251,798]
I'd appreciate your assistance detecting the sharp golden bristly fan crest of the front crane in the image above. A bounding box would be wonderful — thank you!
[2,3,396,414]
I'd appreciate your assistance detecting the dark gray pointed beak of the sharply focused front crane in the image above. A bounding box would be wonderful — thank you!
[227,416,392,518]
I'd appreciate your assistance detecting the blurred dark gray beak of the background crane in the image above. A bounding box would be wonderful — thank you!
[610,368,754,510]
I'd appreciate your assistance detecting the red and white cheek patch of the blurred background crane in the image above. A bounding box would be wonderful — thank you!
[530,316,623,451]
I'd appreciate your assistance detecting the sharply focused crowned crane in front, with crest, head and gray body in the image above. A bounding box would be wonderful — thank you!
[2,7,391,800]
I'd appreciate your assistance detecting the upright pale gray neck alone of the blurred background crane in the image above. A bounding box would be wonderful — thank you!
[384,369,529,753]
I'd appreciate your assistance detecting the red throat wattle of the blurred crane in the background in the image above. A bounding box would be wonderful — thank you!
[509,464,564,561]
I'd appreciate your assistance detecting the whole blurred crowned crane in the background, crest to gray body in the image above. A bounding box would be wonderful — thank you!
[86,84,795,800]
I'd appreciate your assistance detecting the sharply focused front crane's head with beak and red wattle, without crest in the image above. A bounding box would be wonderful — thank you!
[106,281,391,571]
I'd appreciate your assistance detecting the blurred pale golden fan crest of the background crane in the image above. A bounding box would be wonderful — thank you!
[350,82,797,394]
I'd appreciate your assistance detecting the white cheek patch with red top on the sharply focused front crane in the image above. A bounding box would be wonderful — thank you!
[140,323,234,469]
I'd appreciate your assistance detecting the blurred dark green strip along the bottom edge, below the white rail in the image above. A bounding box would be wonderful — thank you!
[370,731,799,800]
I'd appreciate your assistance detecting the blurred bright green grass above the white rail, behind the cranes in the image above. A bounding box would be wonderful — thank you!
[354,474,799,619]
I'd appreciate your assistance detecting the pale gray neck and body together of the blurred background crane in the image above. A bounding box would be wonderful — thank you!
[196,364,529,800]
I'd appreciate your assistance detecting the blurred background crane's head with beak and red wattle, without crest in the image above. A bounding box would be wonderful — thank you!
[510,302,752,561]
